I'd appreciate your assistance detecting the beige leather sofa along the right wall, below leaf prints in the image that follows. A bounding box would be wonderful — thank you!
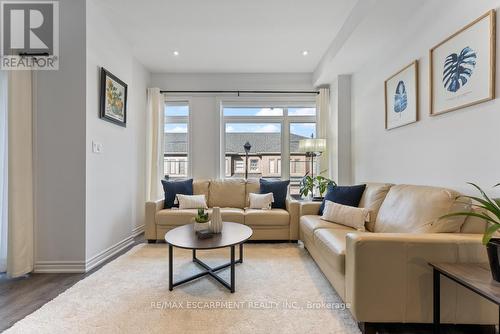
[300,183,498,332]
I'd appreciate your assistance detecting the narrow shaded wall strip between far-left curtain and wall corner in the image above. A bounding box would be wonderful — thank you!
[34,0,86,267]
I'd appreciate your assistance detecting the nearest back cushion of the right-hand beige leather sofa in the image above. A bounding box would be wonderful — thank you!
[374,185,470,233]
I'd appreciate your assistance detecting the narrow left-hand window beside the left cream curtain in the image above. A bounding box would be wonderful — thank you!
[163,102,189,178]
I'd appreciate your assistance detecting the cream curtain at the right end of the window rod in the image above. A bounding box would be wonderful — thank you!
[316,88,331,177]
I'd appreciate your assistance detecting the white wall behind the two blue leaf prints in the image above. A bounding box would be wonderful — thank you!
[352,0,500,196]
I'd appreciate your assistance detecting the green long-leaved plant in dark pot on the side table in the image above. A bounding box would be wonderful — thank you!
[441,182,500,282]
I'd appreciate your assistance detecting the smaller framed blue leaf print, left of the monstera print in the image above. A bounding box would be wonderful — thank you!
[385,60,418,130]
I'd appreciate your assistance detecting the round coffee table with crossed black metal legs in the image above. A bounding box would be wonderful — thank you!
[165,222,253,292]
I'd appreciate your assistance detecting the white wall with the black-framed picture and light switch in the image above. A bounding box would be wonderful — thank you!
[85,0,151,261]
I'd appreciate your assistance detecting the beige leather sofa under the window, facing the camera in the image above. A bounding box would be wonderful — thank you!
[145,179,300,242]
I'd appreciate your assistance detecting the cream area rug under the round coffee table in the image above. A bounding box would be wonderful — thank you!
[6,244,360,334]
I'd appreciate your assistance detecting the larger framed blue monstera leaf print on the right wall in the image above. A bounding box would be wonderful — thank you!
[429,10,496,115]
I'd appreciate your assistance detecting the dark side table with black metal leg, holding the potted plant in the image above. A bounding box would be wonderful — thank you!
[429,263,500,334]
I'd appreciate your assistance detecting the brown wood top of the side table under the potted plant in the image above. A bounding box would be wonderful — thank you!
[429,263,500,305]
